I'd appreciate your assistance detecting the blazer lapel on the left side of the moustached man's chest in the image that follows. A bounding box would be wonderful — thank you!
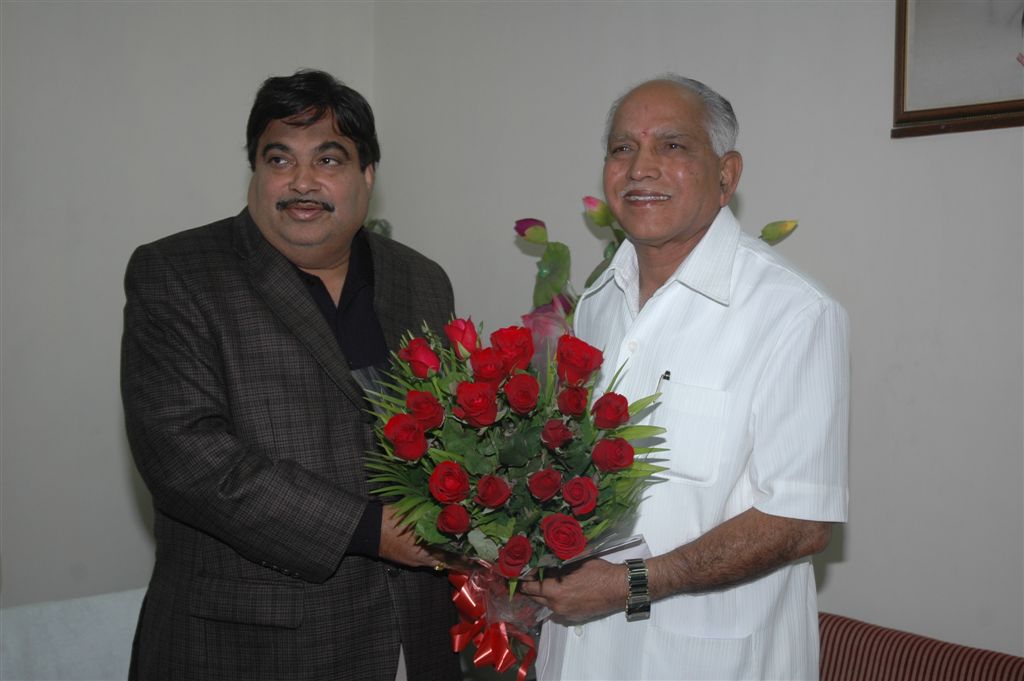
[234,209,366,410]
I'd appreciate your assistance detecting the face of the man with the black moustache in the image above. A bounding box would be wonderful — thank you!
[249,116,374,269]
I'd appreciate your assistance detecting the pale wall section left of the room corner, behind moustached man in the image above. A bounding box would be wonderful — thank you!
[0,1,374,605]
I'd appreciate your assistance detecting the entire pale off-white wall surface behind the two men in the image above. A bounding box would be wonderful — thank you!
[0,0,1024,654]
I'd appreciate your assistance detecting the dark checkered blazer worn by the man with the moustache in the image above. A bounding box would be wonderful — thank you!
[121,211,461,681]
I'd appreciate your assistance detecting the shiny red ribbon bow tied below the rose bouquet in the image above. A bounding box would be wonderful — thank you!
[449,570,537,681]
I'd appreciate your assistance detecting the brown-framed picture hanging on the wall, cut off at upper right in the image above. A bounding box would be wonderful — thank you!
[892,0,1024,137]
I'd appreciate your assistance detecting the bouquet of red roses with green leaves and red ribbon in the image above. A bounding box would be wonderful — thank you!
[368,318,664,671]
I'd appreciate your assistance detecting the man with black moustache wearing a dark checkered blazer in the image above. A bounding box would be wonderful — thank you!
[121,71,461,681]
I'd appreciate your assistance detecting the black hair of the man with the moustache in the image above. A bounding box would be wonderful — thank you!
[246,69,381,170]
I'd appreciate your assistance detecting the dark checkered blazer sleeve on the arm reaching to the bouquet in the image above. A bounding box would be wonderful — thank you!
[121,241,367,582]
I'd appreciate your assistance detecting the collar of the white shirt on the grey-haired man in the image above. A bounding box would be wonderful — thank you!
[584,206,740,305]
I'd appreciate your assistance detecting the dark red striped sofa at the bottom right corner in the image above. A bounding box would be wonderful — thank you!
[818,612,1024,681]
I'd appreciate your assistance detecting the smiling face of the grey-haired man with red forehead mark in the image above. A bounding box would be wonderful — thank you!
[604,81,742,262]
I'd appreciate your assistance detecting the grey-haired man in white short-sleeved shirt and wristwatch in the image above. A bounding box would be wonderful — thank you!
[521,76,849,680]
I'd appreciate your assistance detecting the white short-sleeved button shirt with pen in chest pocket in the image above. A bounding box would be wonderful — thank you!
[538,208,849,680]
